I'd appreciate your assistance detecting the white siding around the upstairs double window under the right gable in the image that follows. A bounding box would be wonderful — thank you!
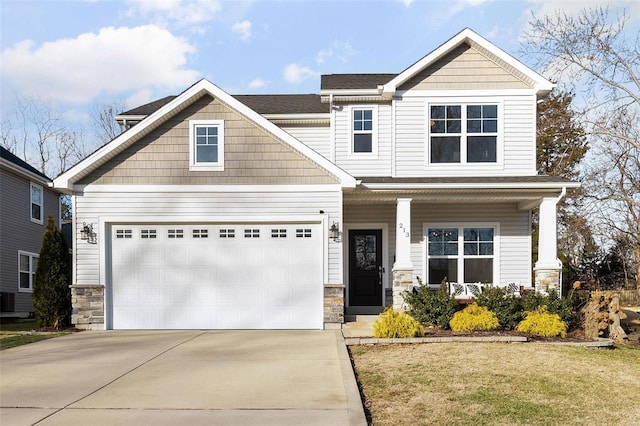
[393,91,536,177]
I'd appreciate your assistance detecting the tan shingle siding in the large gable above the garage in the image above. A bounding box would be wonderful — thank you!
[78,96,338,185]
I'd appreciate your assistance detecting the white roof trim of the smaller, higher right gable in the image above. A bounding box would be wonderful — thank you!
[379,28,554,97]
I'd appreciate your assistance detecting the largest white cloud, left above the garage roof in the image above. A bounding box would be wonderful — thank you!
[0,25,198,104]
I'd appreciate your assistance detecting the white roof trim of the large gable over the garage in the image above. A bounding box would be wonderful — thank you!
[54,79,356,190]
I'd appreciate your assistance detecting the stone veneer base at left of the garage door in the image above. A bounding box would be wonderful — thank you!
[69,285,105,330]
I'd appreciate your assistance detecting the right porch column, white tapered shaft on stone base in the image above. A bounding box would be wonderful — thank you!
[534,197,562,294]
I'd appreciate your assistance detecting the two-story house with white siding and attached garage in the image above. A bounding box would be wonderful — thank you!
[55,29,578,329]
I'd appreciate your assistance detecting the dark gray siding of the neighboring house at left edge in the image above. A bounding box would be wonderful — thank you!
[0,169,60,312]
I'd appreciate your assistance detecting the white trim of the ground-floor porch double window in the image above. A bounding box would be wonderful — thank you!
[422,222,501,285]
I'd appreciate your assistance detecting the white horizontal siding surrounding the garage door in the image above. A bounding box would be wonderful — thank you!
[73,186,342,285]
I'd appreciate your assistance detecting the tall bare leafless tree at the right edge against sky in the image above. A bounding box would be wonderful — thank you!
[523,8,640,287]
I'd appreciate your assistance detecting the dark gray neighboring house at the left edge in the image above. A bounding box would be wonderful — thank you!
[0,147,60,315]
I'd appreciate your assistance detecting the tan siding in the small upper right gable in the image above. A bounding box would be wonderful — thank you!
[399,44,531,90]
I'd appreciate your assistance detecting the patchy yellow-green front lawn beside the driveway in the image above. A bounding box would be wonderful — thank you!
[350,343,640,425]
